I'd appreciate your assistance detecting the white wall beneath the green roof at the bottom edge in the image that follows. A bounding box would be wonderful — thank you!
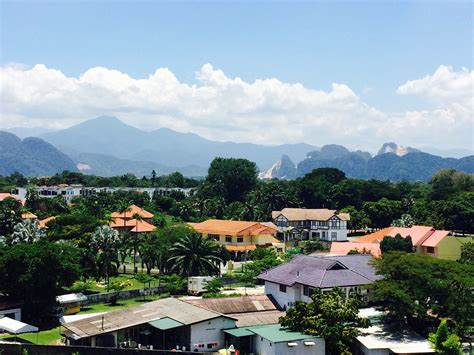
[254,335,326,355]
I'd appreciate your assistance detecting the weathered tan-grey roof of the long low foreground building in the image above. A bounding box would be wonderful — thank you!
[63,298,233,339]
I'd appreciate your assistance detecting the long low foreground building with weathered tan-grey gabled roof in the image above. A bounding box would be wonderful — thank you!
[62,298,236,352]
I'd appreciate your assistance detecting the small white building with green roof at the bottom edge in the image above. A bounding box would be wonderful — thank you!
[224,324,326,355]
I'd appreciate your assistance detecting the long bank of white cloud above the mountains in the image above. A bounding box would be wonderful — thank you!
[0,64,474,149]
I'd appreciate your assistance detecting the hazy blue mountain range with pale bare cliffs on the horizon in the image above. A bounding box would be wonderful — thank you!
[0,116,474,181]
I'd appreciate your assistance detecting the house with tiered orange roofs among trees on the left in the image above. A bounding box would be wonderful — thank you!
[110,205,156,233]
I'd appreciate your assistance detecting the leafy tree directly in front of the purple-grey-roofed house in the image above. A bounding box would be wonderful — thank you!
[280,288,370,355]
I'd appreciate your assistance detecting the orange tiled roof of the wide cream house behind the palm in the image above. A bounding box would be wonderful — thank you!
[191,219,276,236]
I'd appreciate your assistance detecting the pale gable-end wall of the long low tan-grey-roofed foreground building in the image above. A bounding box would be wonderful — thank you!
[190,317,235,351]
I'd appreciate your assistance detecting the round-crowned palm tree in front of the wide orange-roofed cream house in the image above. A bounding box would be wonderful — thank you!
[168,233,223,277]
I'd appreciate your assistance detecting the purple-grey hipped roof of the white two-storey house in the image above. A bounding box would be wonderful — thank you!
[258,255,381,288]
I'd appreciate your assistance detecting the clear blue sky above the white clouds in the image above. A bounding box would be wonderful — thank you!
[1,1,473,151]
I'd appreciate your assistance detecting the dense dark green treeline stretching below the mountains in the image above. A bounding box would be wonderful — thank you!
[0,158,474,233]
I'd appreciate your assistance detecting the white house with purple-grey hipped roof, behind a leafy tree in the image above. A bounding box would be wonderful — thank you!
[257,255,380,309]
